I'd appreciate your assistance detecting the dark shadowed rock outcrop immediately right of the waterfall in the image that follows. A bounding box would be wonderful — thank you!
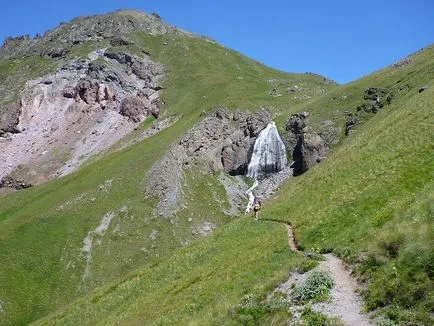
[285,112,326,176]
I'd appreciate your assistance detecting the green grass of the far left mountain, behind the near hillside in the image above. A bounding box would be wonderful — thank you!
[0,11,334,324]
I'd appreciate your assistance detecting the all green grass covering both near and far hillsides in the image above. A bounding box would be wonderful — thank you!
[0,10,434,325]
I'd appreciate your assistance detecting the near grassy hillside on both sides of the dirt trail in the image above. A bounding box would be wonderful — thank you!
[32,49,434,325]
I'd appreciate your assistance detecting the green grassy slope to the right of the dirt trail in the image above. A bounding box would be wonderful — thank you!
[266,77,434,324]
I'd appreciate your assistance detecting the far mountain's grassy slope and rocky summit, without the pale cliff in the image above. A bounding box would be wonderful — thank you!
[0,11,334,324]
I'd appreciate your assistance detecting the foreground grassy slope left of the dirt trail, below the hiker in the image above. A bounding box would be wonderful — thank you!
[38,220,303,325]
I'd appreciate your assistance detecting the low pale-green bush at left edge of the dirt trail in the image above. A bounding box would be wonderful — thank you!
[292,271,333,303]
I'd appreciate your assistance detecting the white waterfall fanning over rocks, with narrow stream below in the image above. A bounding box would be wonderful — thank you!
[246,121,288,213]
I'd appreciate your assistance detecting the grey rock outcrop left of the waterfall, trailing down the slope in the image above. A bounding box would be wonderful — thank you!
[145,109,270,217]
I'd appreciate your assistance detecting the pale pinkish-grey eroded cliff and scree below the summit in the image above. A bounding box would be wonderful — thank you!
[0,49,164,184]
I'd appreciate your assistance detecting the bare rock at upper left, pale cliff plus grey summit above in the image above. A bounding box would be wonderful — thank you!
[0,11,181,186]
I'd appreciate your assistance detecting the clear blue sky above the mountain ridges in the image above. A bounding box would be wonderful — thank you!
[0,0,434,83]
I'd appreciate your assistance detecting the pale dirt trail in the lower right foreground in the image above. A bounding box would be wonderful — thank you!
[283,223,372,326]
